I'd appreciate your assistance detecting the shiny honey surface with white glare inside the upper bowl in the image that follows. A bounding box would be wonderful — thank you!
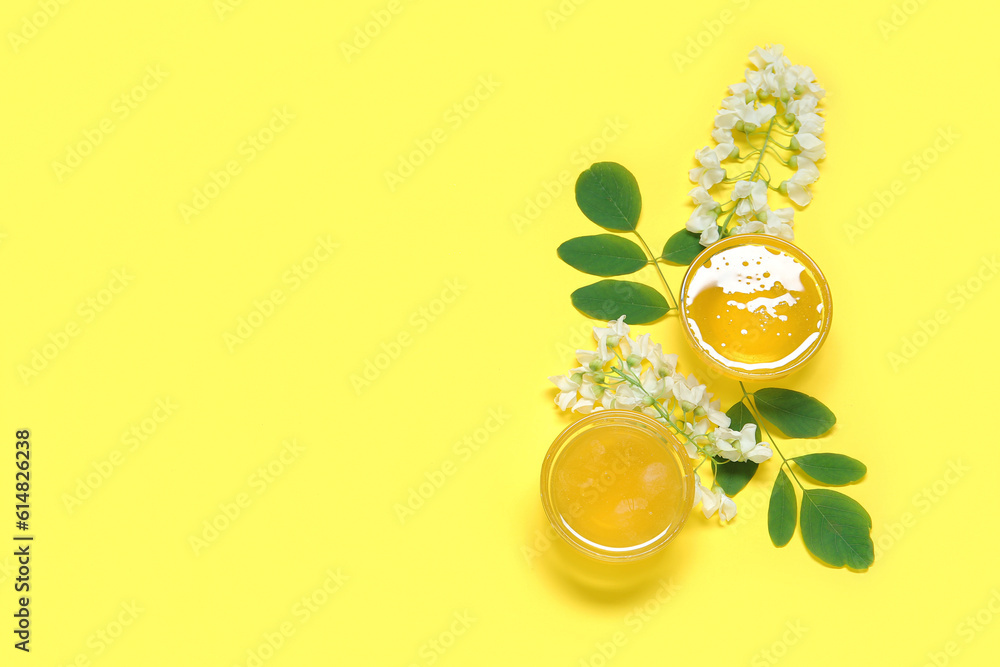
[684,245,827,372]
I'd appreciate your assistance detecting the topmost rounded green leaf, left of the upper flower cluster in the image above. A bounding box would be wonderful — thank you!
[576,162,642,232]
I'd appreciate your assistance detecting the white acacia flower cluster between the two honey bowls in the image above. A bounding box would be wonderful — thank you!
[549,316,772,521]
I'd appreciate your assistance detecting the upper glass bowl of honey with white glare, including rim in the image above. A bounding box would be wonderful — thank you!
[679,234,833,380]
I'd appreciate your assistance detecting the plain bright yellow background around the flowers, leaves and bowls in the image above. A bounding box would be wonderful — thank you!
[0,0,1000,667]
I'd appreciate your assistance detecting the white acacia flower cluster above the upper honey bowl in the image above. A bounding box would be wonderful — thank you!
[685,44,826,246]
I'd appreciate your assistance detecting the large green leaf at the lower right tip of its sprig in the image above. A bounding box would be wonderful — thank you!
[802,489,875,570]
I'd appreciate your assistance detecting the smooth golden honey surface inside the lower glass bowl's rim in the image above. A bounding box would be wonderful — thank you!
[552,425,690,550]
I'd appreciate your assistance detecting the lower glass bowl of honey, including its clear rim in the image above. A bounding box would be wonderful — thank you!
[541,410,694,561]
